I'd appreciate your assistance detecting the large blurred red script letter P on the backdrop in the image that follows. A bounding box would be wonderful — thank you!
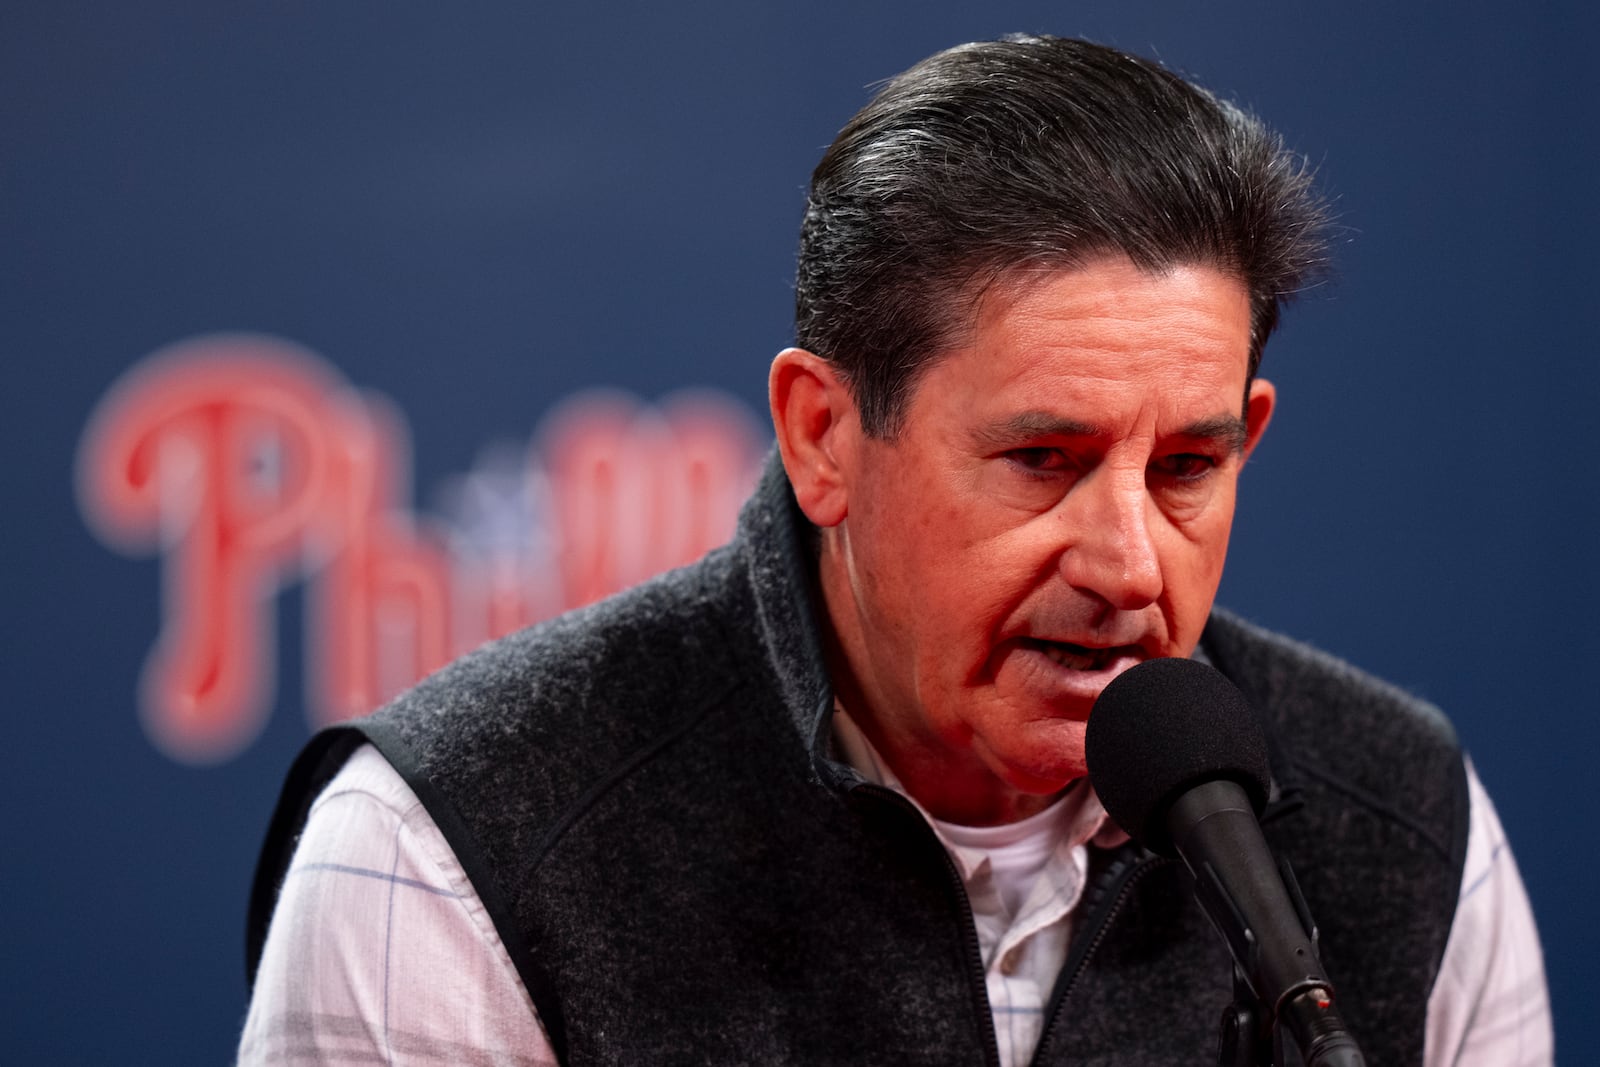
[78,334,341,763]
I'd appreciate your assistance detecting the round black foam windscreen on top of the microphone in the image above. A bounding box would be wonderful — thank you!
[1085,659,1269,856]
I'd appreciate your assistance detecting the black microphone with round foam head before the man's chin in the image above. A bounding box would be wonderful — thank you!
[1085,659,1366,1067]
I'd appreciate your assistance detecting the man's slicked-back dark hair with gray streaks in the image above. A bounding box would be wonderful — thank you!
[795,37,1328,438]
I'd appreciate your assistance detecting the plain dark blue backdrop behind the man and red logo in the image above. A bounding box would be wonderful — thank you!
[0,0,1600,1062]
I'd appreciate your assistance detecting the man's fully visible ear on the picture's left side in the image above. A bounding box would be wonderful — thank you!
[766,349,861,526]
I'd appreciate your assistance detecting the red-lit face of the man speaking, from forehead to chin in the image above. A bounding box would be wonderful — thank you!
[822,258,1272,822]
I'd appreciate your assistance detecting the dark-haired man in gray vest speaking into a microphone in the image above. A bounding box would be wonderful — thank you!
[240,38,1550,1065]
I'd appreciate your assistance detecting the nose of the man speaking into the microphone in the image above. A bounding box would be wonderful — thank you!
[1061,466,1162,611]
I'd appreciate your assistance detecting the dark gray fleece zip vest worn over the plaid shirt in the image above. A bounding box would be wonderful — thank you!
[250,464,1467,1067]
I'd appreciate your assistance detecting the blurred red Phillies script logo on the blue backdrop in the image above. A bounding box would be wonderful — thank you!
[77,334,766,763]
